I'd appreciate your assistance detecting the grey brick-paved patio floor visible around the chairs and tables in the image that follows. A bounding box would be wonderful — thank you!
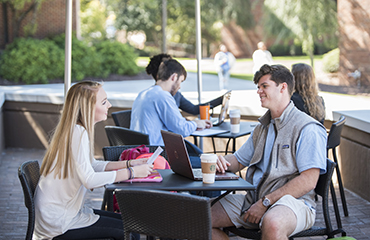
[0,149,370,240]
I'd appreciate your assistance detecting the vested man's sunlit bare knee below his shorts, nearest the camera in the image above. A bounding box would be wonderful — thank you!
[261,205,297,240]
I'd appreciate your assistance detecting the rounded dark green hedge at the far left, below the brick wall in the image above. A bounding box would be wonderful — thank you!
[0,38,64,84]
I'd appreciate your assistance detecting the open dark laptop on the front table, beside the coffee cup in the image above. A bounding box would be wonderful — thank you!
[161,130,239,181]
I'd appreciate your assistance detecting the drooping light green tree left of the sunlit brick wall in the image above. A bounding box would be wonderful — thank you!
[264,0,338,66]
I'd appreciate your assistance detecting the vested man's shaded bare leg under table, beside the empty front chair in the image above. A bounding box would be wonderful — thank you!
[211,202,233,240]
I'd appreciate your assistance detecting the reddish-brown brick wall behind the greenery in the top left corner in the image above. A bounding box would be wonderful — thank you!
[0,0,76,48]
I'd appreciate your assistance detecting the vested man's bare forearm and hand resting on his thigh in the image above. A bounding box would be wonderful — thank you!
[244,168,320,224]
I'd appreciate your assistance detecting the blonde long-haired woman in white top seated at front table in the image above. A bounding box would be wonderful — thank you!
[33,81,153,239]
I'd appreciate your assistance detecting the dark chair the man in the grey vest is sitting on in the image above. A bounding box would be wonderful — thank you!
[224,159,346,239]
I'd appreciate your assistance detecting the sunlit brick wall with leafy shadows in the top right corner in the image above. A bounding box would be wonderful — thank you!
[338,0,370,86]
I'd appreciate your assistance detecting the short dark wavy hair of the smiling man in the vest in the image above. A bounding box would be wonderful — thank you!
[253,64,295,96]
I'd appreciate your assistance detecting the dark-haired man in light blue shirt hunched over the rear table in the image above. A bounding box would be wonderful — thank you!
[130,59,212,145]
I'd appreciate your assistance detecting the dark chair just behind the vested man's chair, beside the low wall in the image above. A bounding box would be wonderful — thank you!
[326,116,348,217]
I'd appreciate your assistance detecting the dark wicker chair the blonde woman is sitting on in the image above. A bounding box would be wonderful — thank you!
[18,160,112,240]
